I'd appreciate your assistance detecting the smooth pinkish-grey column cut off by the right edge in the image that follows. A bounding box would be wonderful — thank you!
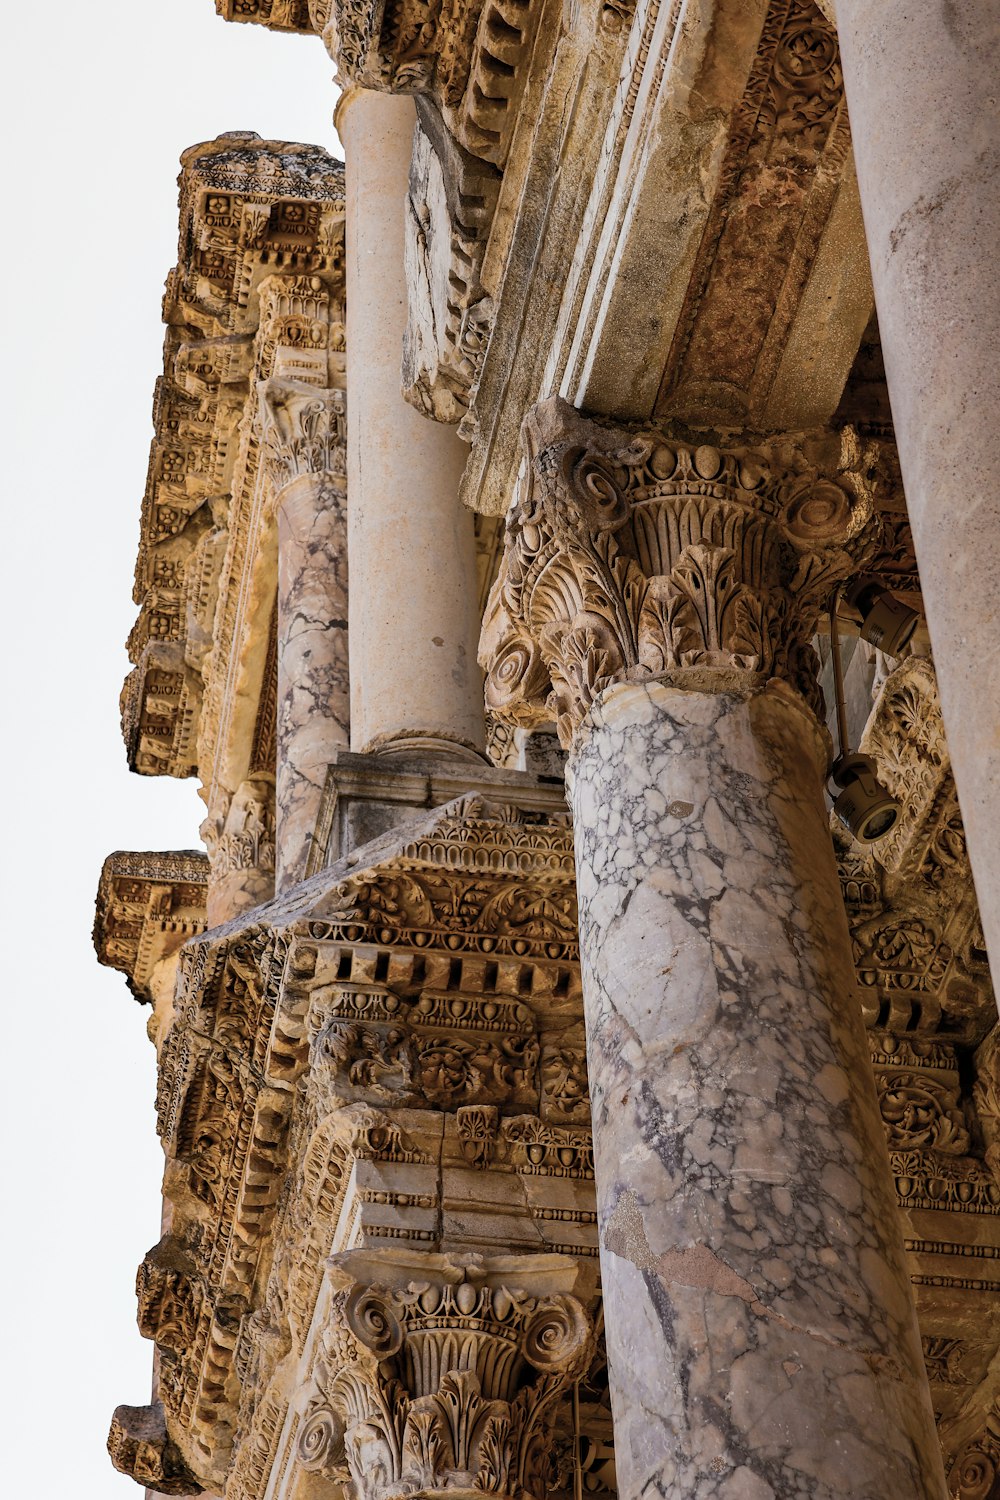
[837,0,1000,978]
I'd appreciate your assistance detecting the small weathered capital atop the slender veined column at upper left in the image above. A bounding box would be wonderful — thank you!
[258,380,348,494]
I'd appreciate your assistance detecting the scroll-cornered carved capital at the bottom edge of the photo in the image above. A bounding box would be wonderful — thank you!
[298,1250,594,1500]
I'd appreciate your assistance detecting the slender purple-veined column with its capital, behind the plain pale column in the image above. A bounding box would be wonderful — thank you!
[261,381,349,891]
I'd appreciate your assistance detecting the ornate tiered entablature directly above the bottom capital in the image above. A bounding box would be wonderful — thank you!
[119,795,597,1500]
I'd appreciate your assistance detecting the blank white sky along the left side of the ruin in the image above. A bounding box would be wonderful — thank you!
[0,0,342,1500]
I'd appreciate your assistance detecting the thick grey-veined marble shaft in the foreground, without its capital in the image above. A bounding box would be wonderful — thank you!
[570,684,945,1500]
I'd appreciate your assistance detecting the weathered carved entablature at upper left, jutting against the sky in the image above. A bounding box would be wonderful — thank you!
[121,132,345,798]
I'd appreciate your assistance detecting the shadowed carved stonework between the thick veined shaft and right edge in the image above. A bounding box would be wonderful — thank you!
[834,657,1000,1476]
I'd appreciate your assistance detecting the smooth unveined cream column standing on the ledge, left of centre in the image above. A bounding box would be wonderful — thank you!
[336,87,484,759]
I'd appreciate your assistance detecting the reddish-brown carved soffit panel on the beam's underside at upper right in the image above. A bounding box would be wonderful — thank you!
[655,0,864,426]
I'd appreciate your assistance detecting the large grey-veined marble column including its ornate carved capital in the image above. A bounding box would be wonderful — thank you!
[484,402,945,1500]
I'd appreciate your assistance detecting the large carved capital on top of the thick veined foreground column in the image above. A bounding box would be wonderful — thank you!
[480,398,879,746]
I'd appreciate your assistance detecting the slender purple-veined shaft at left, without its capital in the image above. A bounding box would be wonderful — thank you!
[276,474,351,891]
